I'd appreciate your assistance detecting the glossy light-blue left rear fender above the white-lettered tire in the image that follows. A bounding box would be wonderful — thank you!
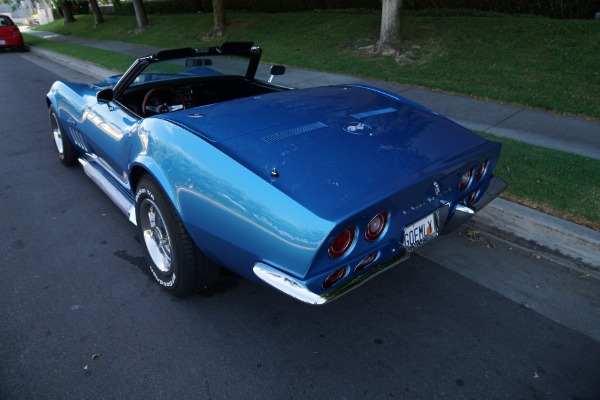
[131,118,334,277]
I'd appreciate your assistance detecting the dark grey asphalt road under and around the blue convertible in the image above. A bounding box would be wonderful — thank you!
[0,52,600,400]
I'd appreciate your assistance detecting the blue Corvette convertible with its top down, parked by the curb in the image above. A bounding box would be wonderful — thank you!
[47,42,506,304]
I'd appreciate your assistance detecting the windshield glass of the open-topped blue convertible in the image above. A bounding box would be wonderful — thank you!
[132,55,250,85]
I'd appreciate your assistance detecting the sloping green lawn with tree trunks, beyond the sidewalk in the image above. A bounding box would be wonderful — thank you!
[35,13,600,119]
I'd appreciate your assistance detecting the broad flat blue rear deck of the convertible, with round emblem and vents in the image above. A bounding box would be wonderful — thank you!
[158,86,486,220]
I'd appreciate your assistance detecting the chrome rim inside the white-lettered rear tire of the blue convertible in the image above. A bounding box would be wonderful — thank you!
[139,198,172,274]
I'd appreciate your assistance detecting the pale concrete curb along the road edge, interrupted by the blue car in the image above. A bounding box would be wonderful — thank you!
[31,47,600,273]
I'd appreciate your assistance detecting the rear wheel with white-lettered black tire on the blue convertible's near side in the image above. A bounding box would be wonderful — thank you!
[135,175,219,297]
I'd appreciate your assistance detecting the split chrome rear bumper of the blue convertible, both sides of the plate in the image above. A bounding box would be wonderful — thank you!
[253,177,507,305]
